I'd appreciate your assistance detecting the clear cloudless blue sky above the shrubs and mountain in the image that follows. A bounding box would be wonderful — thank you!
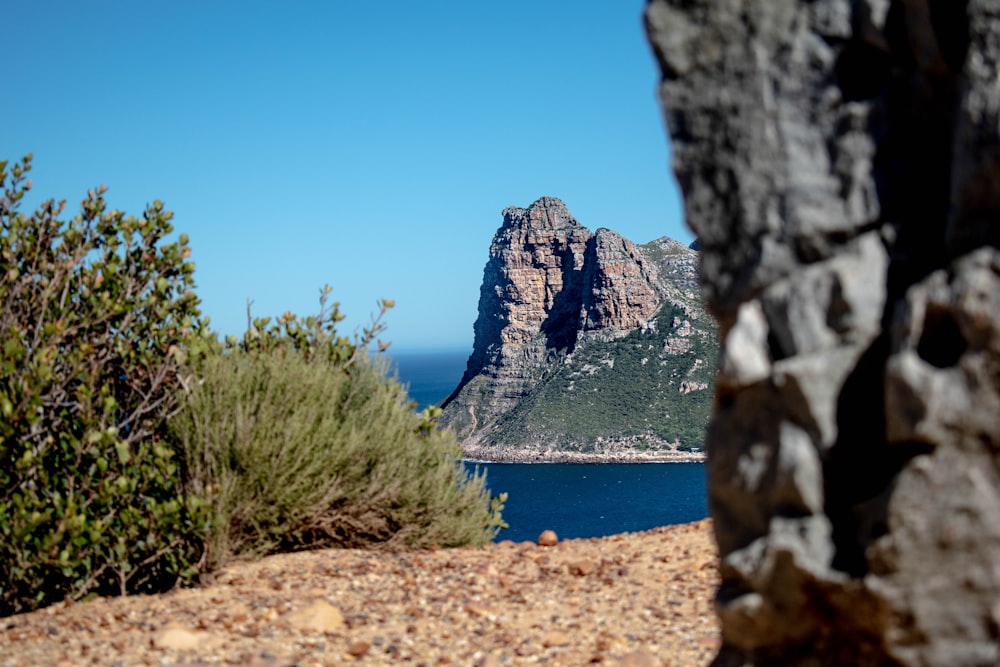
[0,0,692,351]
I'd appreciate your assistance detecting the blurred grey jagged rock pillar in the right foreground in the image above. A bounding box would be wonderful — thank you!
[646,0,1000,666]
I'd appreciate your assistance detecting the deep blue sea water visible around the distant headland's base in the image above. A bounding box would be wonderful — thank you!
[393,350,708,542]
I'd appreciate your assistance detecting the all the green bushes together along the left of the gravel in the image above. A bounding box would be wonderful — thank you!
[0,156,503,615]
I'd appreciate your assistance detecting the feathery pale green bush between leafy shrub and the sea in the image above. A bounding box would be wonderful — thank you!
[170,288,502,568]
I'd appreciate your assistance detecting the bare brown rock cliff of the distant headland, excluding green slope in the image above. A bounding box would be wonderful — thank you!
[443,197,712,462]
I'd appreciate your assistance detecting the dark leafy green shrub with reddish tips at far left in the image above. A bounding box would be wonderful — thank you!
[0,155,208,614]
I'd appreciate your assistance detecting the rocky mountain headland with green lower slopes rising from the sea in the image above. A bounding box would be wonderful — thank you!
[442,197,715,460]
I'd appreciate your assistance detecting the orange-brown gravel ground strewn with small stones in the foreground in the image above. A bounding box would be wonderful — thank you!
[0,520,719,667]
